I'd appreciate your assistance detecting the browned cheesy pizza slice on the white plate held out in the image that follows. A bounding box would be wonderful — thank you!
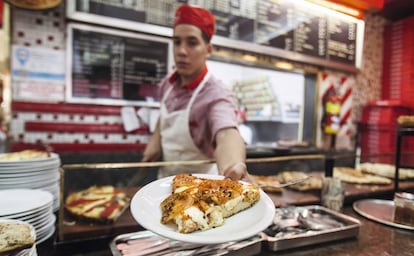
[160,174,260,233]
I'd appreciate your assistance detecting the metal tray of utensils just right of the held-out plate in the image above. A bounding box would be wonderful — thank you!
[263,205,361,251]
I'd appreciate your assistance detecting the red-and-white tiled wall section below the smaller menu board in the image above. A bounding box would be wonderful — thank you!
[10,101,149,152]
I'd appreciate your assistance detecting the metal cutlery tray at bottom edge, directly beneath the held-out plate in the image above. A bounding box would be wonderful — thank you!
[109,231,263,256]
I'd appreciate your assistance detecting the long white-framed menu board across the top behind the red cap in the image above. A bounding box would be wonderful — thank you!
[68,0,364,68]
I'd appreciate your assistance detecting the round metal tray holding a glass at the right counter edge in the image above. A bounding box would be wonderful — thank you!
[352,199,414,230]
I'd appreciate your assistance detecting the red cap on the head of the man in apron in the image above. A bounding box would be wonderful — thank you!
[174,4,215,39]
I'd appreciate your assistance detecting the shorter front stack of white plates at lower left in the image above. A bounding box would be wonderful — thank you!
[0,189,56,244]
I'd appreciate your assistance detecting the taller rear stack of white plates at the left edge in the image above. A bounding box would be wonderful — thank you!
[0,153,61,211]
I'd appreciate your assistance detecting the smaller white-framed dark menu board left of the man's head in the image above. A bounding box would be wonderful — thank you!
[67,24,170,105]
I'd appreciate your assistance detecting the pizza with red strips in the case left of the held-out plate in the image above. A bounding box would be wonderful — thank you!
[65,185,130,222]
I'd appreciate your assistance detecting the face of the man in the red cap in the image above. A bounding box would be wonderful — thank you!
[173,24,212,82]
